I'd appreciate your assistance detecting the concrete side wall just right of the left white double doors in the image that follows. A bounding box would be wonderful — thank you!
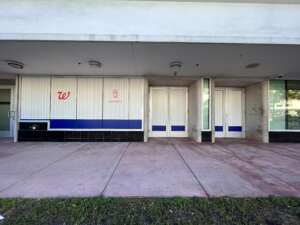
[188,80,202,142]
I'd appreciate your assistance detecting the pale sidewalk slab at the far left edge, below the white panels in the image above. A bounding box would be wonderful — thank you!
[0,143,81,192]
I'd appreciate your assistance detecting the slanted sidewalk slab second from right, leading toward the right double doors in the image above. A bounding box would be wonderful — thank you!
[176,143,267,197]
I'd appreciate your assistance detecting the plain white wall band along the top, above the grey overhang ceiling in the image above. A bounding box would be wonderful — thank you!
[0,0,300,44]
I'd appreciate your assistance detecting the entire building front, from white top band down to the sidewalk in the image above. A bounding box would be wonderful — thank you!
[0,0,300,143]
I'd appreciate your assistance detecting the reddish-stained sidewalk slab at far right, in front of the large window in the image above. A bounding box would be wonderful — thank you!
[214,142,300,196]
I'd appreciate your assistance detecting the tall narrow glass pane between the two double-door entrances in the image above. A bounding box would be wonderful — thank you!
[202,79,210,130]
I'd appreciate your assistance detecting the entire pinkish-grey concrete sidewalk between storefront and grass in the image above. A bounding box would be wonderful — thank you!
[0,139,300,198]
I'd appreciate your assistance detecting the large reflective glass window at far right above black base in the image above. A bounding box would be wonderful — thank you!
[269,80,300,130]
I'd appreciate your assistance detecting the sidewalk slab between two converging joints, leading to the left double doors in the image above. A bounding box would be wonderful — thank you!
[104,140,205,197]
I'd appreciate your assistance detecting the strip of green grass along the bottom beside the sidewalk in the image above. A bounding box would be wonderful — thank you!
[0,197,300,225]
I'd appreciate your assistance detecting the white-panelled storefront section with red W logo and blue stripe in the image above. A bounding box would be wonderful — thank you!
[18,76,147,141]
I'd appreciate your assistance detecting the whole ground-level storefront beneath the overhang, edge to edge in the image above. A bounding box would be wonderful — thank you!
[0,75,300,143]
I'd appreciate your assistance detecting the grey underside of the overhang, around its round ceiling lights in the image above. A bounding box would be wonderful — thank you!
[0,41,300,82]
